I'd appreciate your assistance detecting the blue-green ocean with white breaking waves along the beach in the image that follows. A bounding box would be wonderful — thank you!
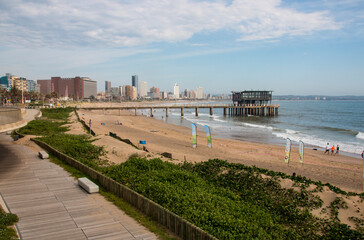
[137,100,364,157]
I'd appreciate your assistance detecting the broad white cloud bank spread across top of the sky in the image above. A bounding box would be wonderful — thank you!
[0,0,341,47]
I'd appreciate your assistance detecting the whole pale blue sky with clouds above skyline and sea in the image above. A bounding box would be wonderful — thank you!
[0,0,364,96]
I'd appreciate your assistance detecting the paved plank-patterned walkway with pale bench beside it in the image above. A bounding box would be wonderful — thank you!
[0,134,156,240]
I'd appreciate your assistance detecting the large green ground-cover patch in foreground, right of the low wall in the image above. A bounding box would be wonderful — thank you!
[103,158,362,239]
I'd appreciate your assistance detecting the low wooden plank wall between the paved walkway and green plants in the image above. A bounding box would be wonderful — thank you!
[31,138,217,240]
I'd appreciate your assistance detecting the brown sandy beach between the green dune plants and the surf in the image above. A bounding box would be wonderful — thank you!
[74,106,363,193]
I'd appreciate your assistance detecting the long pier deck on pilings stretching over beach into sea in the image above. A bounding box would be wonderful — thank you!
[78,104,279,117]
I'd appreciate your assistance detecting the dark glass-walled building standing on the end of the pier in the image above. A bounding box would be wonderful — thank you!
[232,90,273,106]
